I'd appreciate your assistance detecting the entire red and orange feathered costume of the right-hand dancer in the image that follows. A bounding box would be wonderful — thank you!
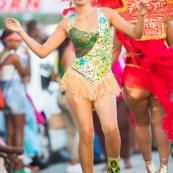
[94,0,173,141]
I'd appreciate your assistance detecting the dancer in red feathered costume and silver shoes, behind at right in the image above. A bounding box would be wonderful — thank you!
[94,0,173,173]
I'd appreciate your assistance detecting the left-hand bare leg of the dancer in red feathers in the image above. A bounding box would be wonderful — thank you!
[123,87,152,162]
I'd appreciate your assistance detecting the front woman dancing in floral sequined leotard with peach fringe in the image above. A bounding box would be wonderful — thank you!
[5,0,149,173]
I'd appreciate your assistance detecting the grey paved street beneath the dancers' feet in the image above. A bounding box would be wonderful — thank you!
[38,152,173,173]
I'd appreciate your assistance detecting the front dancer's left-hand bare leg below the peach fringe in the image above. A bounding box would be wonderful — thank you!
[66,92,94,173]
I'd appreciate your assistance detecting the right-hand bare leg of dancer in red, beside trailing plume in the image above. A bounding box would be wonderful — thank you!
[150,96,171,172]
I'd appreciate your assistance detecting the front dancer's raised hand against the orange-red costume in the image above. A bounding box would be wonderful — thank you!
[138,0,150,16]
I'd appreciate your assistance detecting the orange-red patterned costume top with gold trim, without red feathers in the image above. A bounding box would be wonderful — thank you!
[119,0,173,39]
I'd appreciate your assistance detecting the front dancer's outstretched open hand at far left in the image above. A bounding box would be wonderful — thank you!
[5,18,22,33]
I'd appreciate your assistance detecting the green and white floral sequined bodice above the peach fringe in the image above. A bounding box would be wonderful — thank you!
[69,9,113,82]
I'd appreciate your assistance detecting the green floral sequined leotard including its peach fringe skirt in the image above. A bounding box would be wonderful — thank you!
[60,9,120,101]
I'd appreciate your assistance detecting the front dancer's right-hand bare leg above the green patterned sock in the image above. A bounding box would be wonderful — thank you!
[94,95,121,158]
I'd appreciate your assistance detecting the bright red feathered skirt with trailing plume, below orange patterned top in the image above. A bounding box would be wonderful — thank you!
[117,31,173,141]
